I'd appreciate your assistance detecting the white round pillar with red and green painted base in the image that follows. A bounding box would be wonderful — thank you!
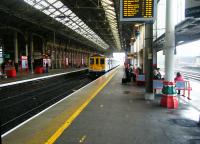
[160,0,178,109]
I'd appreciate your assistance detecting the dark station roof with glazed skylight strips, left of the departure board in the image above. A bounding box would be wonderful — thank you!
[0,0,121,50]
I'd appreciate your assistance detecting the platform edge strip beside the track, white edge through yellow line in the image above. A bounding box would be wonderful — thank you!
[2,67,116,144]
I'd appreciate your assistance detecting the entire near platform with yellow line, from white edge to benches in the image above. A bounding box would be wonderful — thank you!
[2,67,200,144]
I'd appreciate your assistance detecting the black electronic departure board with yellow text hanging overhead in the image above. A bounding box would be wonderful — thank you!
[120,0,156,21]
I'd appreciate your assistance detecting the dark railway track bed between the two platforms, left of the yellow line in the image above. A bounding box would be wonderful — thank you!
[0,73,92,133]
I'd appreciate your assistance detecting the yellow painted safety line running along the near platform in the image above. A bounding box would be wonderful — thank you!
[45,70,117,144]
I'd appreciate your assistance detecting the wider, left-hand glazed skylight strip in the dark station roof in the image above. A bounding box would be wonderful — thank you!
[24,0,109,49]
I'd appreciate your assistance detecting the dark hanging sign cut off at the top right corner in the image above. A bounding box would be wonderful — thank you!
[185,0,200,18]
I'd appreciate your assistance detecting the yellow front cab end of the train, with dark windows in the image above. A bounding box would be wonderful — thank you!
[89,57,105,77]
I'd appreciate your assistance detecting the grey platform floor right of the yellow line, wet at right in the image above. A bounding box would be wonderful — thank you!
[55,69,200,144]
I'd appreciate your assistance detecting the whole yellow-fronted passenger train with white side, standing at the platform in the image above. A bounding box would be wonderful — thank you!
[89,54,119,77]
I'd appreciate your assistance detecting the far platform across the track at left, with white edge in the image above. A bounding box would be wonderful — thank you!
[0,67,87,87]
